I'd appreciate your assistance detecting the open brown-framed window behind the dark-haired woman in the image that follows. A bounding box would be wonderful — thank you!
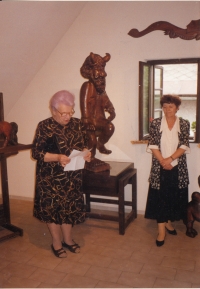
[139,58,200,142]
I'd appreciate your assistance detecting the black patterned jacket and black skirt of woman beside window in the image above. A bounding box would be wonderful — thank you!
[145,118,190,223]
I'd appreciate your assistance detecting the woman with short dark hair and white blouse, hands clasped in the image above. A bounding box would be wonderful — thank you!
[145,95,190,246]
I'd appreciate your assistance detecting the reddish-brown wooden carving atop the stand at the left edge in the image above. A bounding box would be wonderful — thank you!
[0,121,18,148]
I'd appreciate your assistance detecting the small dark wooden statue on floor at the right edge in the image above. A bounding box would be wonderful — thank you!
[186,176,200,238]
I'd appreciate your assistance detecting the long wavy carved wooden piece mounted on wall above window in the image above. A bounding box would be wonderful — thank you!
[128,19,200,40]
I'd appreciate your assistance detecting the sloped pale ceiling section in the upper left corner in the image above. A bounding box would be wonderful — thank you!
[0,1,87,118]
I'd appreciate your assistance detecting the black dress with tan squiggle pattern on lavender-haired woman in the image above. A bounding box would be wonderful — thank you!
[32,117,87,225]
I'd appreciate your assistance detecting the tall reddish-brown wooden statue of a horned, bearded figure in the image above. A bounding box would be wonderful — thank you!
[80,52,115,172]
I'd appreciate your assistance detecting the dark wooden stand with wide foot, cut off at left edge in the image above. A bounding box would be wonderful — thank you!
[0,144,32,242]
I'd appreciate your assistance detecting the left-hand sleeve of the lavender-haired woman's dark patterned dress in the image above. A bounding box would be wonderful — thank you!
[32,123,47,161]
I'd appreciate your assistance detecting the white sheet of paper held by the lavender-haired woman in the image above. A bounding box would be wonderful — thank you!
[64,150,89,171]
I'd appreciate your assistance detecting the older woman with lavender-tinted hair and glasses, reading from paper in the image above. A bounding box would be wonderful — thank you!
[32,90,91,258]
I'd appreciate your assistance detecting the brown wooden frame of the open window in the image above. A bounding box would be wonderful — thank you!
[139,58,200,143]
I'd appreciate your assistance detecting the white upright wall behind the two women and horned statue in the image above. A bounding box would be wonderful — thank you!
[7,1,200,212]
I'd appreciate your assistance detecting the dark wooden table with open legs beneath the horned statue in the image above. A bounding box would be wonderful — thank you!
[83,162,137,235]
